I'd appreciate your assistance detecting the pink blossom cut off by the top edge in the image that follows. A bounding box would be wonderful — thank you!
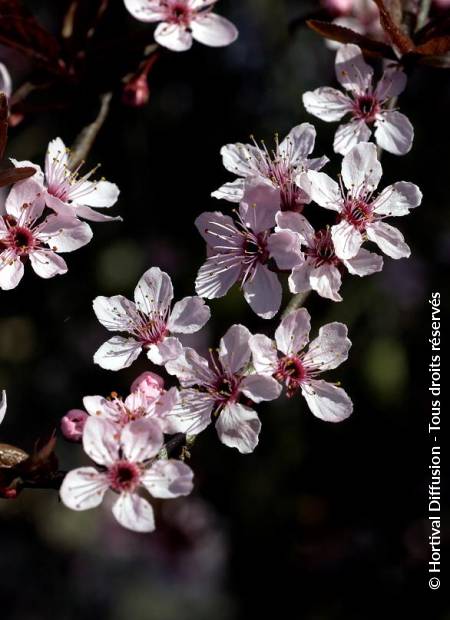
[124,0,238,52]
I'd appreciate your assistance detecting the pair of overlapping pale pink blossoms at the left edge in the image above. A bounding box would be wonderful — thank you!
[0,138,121,290]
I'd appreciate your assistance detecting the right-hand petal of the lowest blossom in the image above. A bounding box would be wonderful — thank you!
[142,459,194,499]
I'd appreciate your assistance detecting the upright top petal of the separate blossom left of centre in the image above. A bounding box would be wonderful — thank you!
[134,267,173,316]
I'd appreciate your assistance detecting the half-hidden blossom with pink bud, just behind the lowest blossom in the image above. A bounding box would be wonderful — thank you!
[83,373,178,431]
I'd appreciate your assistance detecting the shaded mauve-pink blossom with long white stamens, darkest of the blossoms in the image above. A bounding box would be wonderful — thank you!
[195,180,302,319]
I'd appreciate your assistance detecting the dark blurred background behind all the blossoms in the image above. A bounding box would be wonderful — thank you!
[0,0,450,620]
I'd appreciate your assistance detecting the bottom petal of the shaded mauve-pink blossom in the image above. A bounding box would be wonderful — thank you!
[243,263,283,319]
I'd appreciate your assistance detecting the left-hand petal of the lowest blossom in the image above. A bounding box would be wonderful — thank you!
[59,467,109,510]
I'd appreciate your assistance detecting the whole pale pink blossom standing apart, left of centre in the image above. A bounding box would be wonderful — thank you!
[93,267,211,370]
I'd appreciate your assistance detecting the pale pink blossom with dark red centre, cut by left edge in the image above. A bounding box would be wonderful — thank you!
[0,179,92,290]
